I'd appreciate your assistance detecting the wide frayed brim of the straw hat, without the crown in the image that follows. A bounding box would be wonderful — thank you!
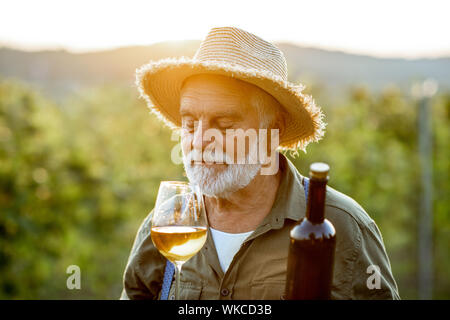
[136,57,325,151]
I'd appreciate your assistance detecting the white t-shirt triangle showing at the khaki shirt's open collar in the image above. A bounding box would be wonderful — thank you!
[209,228,253,272]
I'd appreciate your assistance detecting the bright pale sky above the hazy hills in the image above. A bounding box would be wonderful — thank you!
[0,0,450,58]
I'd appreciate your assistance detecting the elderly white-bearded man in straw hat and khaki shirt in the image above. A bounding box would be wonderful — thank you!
[121,27,399,299]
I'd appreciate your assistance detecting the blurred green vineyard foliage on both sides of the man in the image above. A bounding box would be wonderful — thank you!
[0,81,450,299]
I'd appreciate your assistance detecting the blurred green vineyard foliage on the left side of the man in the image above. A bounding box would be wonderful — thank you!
[0,82,183,299]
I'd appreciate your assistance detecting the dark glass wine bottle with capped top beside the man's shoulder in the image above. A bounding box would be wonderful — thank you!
[285,162,336,300]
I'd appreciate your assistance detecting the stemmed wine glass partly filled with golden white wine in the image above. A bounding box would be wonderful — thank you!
[151,181,207,300]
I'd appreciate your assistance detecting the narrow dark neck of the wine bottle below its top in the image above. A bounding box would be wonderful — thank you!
[306,178,328,223]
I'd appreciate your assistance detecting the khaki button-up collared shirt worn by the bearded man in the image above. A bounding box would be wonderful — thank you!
[121,155,400,300]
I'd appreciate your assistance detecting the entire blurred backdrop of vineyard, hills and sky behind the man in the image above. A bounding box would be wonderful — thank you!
[0,0,450,299]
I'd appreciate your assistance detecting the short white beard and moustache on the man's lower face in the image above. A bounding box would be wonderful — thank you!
[183,150,261,199]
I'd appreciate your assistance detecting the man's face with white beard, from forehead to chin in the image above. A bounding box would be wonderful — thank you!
[180,75,260,197]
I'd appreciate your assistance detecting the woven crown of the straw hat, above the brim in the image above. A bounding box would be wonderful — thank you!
[194,27,287,81]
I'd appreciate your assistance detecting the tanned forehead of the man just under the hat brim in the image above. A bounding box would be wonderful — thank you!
[180,74,254,115]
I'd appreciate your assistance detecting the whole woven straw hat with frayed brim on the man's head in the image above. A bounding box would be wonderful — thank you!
[136,27,325,151]
